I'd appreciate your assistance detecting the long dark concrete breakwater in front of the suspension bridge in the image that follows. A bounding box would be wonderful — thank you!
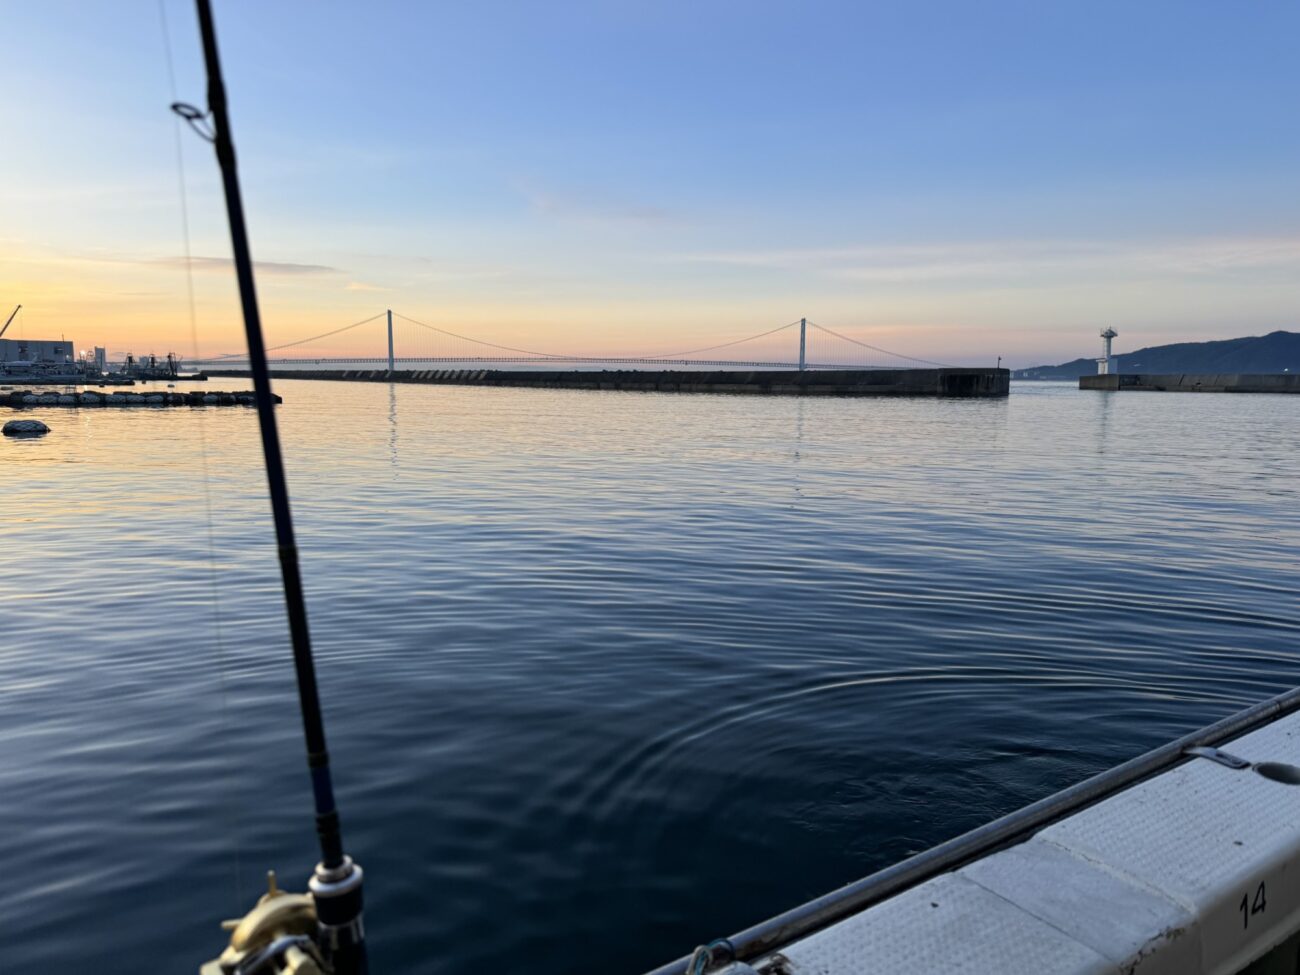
[208,369,1011,397]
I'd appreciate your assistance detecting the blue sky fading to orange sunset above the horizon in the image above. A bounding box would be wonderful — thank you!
[0,0,1300,367]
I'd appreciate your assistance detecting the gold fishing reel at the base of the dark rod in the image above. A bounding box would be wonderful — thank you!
[199,870,334,975]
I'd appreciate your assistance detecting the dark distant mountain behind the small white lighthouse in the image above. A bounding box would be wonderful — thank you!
[1011,332,1300,380]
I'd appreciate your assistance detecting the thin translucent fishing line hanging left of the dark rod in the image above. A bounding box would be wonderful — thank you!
[159,0,244,906]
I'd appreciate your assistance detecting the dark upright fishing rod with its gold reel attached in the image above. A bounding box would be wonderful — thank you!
[172,0,367,975]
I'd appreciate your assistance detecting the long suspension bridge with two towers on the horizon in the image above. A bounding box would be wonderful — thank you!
[187,309,946,372]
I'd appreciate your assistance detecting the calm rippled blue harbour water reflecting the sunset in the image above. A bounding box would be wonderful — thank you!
[0,380,1300,975]
